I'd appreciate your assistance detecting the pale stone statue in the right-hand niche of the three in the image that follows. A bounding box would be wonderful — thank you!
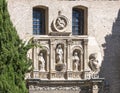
[73,52,80,71]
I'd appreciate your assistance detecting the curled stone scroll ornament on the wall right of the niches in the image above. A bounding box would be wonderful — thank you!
[88,53,100,73]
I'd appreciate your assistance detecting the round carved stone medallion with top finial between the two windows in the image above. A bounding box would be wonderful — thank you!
[53,11,68,32]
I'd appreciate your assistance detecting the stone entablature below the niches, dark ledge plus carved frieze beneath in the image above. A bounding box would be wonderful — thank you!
[28,78,104,93]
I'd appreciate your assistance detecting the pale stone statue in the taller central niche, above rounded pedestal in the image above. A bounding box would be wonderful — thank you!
[56,45,63,63]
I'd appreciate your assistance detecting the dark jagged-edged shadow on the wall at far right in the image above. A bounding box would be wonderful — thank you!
[101,10,120,93]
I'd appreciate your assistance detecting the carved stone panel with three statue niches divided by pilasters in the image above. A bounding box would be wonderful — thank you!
[33,38,84,80]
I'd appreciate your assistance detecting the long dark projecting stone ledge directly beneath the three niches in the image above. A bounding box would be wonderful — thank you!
[27,78,104,86]
